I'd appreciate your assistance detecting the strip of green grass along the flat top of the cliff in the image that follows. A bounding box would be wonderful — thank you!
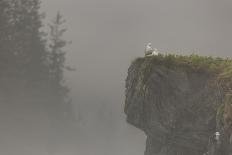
[133,54,232,89]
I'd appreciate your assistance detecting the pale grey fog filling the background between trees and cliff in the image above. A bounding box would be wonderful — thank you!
[5,0,232,155]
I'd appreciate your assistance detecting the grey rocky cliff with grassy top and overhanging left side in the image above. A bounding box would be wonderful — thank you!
[124,55,232,155]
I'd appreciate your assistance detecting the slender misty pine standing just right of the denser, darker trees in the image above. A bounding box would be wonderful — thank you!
[48,12,72,121]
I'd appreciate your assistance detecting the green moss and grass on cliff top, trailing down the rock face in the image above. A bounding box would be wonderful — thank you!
[132,54,232,127]
